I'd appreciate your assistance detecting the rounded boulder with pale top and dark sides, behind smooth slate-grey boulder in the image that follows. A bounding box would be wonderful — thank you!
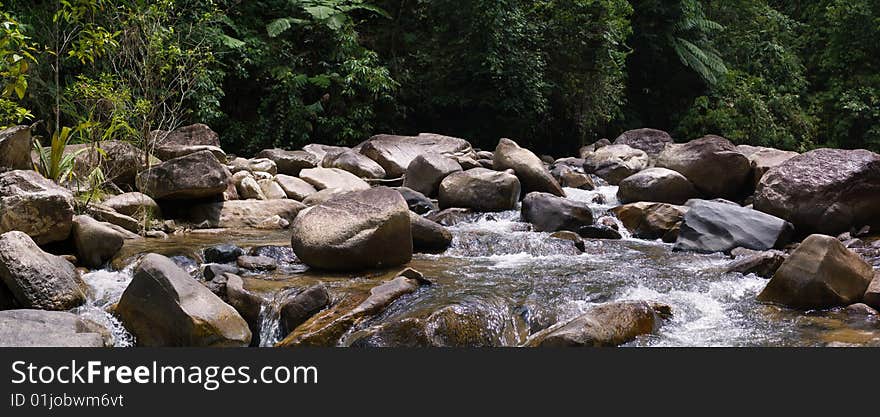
[617,168,699,204]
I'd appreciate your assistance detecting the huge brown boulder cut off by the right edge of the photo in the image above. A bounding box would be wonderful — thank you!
[754,149,880,236]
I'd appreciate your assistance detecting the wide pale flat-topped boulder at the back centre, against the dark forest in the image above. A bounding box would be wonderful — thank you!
[358,133,473,177]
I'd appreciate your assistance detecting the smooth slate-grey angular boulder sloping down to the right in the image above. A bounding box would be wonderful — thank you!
[675,200,794,253]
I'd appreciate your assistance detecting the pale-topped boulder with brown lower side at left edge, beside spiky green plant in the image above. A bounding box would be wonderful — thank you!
[0,171,73,245]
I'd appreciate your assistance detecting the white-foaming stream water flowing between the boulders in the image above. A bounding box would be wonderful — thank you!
[84,186,880,346]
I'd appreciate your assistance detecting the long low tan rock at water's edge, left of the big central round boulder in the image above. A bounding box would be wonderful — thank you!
[186,200,305,229]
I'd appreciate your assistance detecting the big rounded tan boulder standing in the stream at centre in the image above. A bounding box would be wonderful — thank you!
[291,187,413,271]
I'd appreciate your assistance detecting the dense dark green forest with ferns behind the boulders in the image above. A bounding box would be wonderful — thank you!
[0,0,880,154]
